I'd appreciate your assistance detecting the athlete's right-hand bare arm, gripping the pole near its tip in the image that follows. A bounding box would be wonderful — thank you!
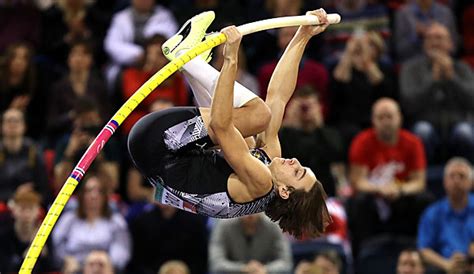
[257,9,328,158]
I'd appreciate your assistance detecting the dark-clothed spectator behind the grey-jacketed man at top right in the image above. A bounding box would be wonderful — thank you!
[393,0,458,61]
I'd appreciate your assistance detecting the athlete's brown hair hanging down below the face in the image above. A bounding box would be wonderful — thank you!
[265,180,332,238]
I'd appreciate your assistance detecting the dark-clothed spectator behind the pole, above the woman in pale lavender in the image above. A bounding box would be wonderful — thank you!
[54,98,120,195]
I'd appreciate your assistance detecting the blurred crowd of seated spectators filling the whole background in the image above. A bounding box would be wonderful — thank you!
[0,0,474,274]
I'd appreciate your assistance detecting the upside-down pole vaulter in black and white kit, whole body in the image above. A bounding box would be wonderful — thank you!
[128,9,331,237]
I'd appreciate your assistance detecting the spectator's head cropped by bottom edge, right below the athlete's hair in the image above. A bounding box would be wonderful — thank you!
[295,251,342,274]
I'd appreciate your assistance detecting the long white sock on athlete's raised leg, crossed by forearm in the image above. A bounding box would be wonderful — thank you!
[183,57,258,108]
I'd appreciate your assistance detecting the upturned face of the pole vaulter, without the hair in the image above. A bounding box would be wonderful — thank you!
[269,157,316,199]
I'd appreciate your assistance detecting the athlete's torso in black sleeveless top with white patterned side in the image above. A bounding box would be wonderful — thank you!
[148,149,275,218]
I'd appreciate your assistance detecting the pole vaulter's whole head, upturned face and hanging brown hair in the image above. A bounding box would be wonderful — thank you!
[265,158,331,237]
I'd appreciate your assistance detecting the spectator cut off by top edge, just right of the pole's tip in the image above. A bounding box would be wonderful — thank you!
[323,0,391,67]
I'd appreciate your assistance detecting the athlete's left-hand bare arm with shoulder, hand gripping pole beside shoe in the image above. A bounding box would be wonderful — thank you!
[209,26,273,200]
